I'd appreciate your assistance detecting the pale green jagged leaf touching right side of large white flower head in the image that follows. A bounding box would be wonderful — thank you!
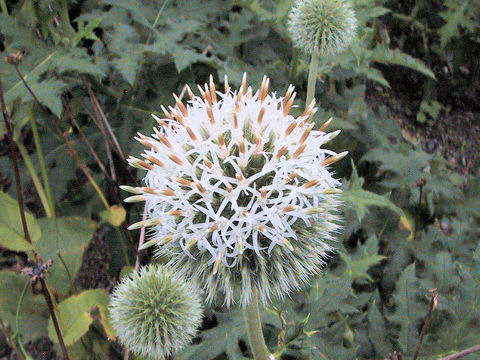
[342,162,403,221]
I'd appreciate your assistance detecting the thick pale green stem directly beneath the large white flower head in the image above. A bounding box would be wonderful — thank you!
[243,291,270,360]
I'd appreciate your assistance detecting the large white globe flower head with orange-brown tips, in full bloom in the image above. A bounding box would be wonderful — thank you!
[122,76,346,306]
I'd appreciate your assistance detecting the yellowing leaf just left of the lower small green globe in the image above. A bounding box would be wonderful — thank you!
[48,289,115,346]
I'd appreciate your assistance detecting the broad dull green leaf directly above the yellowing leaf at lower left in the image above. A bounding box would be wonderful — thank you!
[36,217,96,295]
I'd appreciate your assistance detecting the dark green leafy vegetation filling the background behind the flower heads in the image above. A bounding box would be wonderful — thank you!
[0,0,480,360]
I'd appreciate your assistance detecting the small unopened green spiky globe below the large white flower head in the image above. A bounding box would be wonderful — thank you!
[109,265,203,360]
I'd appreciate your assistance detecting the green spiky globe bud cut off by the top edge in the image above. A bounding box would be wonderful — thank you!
[288,0,357,55]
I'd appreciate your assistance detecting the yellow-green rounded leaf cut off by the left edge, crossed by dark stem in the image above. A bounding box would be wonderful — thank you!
[0,192,42,251]
